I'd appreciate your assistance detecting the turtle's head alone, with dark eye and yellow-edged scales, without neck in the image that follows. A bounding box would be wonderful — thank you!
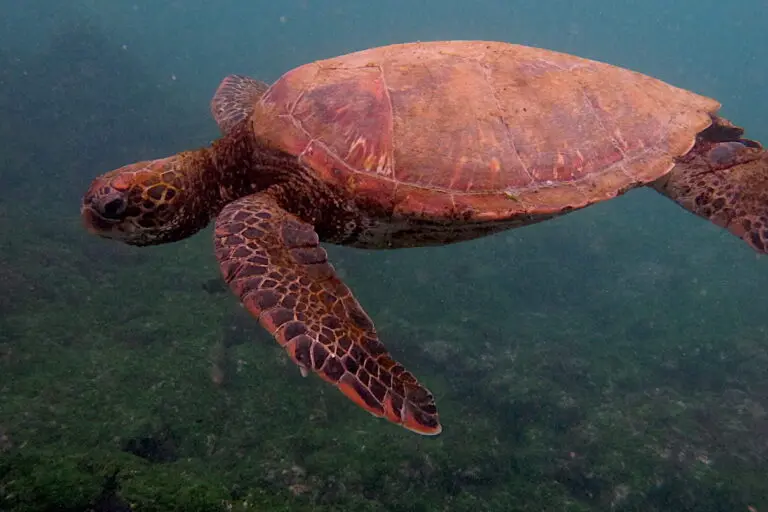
[80,154,210,245]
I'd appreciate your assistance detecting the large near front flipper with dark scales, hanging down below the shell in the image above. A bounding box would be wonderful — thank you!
[215,193,441,434]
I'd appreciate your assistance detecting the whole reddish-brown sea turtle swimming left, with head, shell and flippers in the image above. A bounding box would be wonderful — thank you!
[82,41,768,434]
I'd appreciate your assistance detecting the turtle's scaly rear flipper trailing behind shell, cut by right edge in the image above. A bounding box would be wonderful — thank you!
[653,139,768,253]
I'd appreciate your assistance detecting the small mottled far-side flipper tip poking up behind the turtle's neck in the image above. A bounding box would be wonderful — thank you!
[211,75,269,134]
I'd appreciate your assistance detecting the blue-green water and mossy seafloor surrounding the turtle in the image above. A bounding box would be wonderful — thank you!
[0,0,768,512]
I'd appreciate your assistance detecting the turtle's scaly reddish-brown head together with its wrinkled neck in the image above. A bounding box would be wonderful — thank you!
[81,130,290,246]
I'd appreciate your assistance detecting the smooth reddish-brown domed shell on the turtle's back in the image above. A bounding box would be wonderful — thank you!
[252,41,720,220]
